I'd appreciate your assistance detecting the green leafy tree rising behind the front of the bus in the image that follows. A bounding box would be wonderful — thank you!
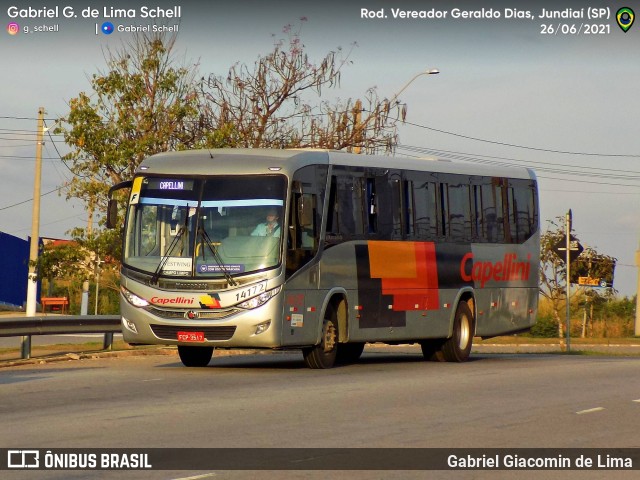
[58,34,202,224]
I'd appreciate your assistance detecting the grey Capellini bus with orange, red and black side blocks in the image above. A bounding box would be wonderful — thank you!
[107,149,540,368]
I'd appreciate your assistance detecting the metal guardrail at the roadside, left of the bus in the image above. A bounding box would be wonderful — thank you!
[0,315,122,358]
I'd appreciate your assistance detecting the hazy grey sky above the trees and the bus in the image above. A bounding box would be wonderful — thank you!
[0,0,640,295]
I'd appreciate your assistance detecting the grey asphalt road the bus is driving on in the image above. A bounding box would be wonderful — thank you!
[0,349,640,479]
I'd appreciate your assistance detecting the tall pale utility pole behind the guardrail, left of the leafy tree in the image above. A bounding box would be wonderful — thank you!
[22,107,44,358]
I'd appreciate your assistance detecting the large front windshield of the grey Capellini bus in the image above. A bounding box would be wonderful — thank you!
[123,175,287,278]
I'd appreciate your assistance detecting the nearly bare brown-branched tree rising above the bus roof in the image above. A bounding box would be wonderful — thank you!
[201,18,406,153]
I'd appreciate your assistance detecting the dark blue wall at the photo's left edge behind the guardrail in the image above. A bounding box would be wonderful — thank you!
[0,232,29,307]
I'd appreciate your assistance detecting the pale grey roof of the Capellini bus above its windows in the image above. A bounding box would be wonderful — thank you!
[136,148,535,179]
